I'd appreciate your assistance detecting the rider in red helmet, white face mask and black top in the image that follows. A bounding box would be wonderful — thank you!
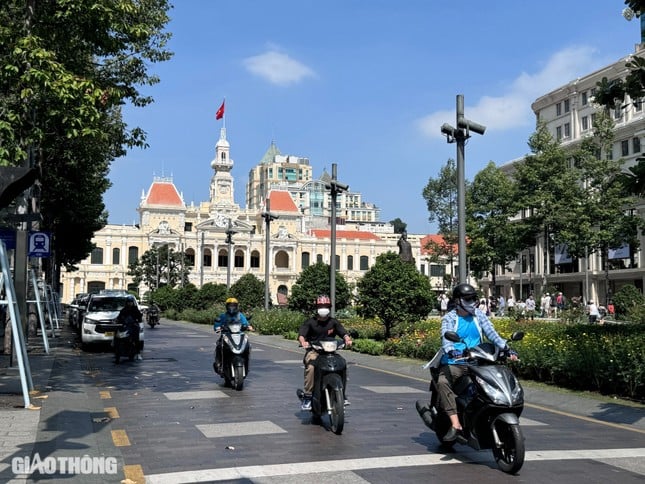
[298,295,352,410]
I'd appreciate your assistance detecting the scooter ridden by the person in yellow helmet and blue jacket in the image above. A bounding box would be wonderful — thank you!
[213,316,251,390]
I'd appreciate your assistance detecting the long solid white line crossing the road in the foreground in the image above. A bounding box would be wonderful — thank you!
[146,448,645,484]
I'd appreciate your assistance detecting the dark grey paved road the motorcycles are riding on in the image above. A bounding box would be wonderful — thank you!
[68,320,645,484]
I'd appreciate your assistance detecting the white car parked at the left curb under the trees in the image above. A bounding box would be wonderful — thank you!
[81,294,144,349]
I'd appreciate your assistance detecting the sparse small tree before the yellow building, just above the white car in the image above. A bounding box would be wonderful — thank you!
[128,245,190,288]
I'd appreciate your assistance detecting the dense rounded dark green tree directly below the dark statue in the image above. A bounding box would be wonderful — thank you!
[356,252,434,338]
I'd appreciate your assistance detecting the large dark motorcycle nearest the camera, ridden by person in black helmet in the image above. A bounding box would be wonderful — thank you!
[416,331,525,474]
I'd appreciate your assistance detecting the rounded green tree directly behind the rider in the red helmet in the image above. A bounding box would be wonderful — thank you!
[289,262,351,314]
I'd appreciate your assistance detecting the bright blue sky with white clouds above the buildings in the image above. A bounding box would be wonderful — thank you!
[105,0,640,234]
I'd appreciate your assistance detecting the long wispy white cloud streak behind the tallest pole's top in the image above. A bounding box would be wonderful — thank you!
[417,46,599,138]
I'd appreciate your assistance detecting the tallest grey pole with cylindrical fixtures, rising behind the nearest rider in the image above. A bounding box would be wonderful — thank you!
[441,94,486,283]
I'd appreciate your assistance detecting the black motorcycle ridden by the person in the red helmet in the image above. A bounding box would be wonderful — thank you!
[296,338,347,435]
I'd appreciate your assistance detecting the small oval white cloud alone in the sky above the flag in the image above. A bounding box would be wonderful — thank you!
[244,50,316,86]
